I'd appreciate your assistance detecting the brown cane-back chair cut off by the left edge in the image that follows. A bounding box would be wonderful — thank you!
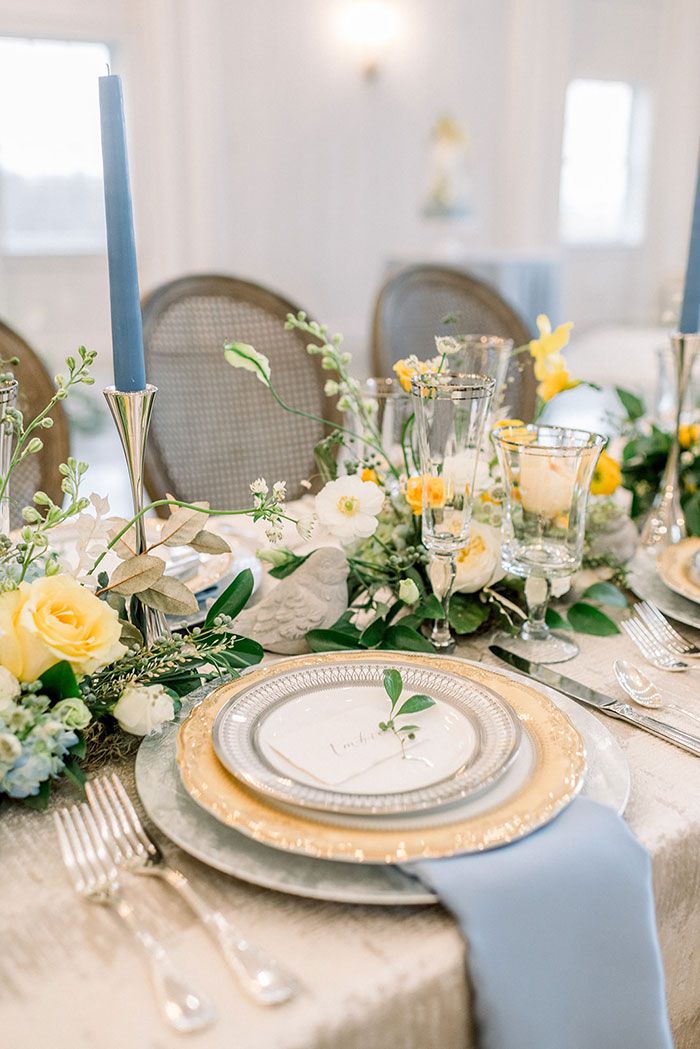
[0,321,70,528]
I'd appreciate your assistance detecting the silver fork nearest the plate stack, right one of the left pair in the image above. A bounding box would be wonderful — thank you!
[85,773,299,1005]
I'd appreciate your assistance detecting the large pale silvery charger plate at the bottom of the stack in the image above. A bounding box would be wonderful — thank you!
[135,661,630,906]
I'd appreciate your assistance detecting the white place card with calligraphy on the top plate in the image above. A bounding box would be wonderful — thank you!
[272,704,427,786]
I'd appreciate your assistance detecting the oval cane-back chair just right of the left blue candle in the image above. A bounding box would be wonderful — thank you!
[144,275,333,509]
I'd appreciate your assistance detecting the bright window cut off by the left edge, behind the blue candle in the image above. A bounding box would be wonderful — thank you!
[0,37,109,255]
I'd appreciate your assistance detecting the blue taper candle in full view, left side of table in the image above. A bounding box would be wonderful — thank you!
[100,76,146,393]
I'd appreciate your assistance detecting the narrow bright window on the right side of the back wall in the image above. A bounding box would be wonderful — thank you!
[559,80,649,244]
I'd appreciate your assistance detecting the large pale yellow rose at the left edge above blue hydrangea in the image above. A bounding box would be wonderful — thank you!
[0,575,126,682]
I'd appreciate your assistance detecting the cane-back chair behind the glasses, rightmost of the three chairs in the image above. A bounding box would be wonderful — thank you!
[372,264,536,422]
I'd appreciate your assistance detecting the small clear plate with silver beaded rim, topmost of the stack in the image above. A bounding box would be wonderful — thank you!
[212,652,521,815]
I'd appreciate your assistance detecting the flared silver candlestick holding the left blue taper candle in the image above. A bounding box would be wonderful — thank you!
[104,384,170,645]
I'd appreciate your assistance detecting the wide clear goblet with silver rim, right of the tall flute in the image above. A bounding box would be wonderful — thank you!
[491,426,606,663]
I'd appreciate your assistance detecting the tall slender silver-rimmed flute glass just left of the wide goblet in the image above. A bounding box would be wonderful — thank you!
[411,372,495,648]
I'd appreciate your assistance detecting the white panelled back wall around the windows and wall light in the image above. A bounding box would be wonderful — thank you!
[0,0,700,381]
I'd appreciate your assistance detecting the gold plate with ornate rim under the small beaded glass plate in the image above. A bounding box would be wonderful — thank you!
[177,652,586,863]
